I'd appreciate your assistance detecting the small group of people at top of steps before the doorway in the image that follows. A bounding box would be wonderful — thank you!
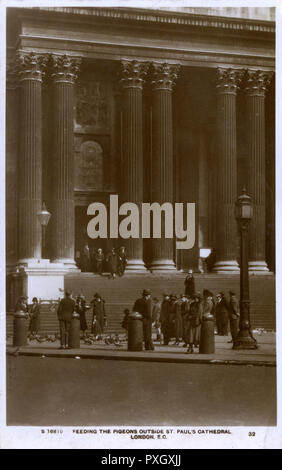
[76,243,127,279]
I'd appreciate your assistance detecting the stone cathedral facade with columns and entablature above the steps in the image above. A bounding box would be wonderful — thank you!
[6,7,275,304]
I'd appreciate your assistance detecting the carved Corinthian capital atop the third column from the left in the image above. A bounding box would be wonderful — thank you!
[120,59,149,88]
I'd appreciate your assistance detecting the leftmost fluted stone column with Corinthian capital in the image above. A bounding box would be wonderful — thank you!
[17,52,47,264]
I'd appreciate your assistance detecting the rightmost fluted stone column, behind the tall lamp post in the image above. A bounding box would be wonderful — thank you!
[246,70,272,273]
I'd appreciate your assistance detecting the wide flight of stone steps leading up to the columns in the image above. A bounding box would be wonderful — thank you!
[7,273,275,335]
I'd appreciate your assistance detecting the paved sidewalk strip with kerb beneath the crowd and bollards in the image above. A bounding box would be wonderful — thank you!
[7,332,276,366]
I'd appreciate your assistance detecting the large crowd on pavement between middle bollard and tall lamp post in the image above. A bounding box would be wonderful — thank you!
[122,289,240,353]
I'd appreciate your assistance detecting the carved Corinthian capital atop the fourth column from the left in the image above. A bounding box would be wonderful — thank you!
[152,62,180,91]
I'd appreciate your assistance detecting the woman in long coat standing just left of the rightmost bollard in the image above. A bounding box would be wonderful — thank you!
[186,294,203,354]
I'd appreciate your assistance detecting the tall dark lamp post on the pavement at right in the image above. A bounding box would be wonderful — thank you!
[233,188,257,349]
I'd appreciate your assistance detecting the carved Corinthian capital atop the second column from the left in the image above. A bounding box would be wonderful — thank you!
[51,54,81,84]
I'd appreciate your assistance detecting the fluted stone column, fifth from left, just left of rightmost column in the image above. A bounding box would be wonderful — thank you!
[213,69,243,273]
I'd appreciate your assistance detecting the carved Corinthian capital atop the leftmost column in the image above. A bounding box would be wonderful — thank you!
[16,51,48,82]
